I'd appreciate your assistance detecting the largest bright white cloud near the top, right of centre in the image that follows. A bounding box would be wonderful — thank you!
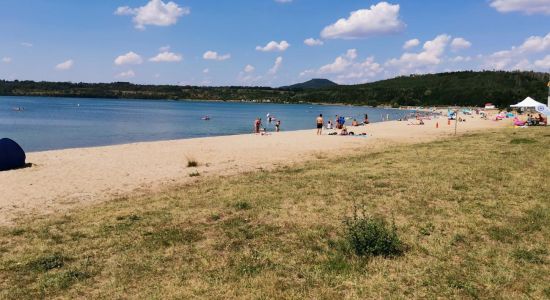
[321,2,405,39]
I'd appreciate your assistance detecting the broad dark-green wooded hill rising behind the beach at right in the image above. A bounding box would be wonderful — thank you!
[288,71,550,107]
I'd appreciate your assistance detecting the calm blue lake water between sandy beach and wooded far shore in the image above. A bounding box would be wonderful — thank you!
[0,97,414,152]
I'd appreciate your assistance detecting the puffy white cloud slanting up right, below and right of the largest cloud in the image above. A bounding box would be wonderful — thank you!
[386,34,451,73]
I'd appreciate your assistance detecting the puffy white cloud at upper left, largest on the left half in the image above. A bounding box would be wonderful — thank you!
[115,0,191,30]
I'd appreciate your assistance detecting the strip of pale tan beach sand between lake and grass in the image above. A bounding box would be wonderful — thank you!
[0,117,510,225]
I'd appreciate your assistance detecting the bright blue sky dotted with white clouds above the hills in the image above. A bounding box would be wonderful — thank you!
[0,0,550,87]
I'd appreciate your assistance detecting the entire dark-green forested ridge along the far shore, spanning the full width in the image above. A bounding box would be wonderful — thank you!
[0,71,550,107]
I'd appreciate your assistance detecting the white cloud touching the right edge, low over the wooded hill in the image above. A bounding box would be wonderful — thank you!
[485,33,550,71]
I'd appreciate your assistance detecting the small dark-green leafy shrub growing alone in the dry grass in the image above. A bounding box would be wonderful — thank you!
[344,206,404,257]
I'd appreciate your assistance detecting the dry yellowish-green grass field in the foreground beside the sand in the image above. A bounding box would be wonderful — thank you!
[0,128,550,299]
